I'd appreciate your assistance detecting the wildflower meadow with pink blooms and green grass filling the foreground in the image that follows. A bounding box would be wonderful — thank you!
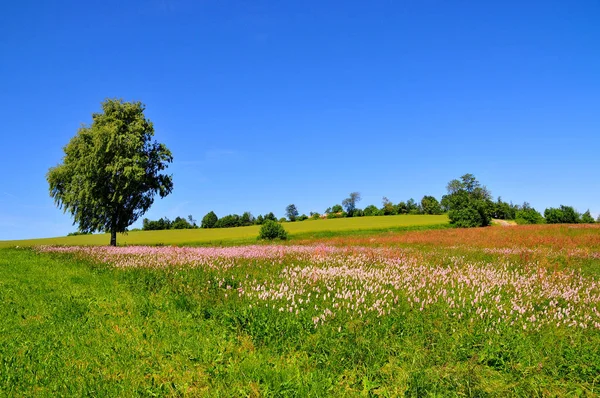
[0,225,600,397]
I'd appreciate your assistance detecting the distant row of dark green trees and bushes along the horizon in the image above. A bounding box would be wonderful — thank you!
[127,174,600,231]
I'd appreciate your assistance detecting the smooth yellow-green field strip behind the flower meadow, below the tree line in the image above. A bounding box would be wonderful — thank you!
[0,215,448,247]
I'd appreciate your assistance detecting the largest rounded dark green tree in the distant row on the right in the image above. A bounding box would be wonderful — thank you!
[441,174,494,228]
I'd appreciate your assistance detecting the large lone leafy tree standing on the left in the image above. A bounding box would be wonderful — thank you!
[46,99,173,246]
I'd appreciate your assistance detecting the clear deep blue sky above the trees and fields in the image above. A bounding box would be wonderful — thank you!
[0,0,600,239]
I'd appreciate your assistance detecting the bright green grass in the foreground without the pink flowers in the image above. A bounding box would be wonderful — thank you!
[0,249,600,397]
